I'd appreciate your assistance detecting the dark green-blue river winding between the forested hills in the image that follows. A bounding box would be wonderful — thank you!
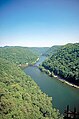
[24,56,79,113]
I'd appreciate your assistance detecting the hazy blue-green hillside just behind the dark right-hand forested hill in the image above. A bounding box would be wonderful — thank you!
[43,45,62,56]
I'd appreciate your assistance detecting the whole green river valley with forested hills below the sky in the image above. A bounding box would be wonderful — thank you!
[0,44,79,119]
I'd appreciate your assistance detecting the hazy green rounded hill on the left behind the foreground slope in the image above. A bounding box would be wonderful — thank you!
[0,46,38,64]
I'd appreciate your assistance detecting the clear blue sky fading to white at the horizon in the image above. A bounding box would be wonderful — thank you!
[0,0,79,47]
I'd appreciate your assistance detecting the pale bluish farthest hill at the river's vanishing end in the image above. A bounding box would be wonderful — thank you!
[29,47,49,56]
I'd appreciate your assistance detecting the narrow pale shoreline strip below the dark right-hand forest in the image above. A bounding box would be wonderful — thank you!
[39,66,79,89]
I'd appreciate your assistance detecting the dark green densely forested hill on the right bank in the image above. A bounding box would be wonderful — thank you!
[40,43,79,86]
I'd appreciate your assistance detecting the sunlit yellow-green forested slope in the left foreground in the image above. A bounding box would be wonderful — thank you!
[0,58,62,119]
